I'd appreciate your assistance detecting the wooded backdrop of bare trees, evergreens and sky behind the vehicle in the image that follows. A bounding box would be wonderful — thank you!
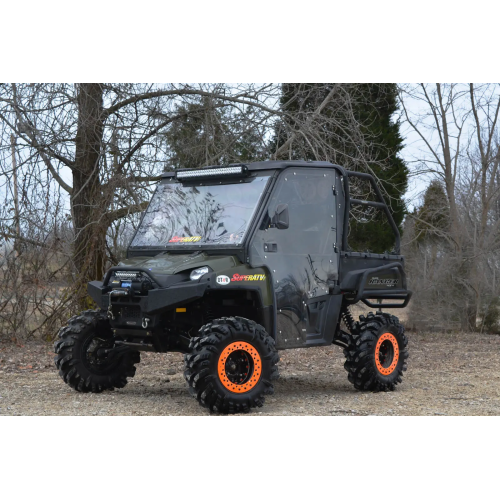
[0,83,500,340]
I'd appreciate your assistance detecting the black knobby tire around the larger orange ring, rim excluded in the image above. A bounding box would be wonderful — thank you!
[184,316,279,414]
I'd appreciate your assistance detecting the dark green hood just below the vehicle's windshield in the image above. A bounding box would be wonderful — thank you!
[118,252,240,274]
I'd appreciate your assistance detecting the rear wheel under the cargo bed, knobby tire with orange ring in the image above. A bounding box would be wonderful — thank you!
[344,312,408,392]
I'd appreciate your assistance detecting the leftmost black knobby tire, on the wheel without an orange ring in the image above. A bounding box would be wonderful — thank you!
[54,311,141,392]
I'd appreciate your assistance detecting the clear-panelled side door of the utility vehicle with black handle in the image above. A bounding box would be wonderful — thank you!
[250,167,340,349]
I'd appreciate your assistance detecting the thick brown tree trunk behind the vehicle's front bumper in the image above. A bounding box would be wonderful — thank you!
[71,83,107,307]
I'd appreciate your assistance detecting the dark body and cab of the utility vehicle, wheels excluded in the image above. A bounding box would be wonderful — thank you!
[88,161,411,352]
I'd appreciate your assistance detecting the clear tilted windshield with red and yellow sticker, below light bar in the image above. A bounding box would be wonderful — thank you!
[130,176,269,247]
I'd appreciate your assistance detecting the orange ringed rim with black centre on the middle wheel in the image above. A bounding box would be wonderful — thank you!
[218,342,262,393]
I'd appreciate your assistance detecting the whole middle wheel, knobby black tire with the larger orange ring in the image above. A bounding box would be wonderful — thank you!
[184,317,279,413]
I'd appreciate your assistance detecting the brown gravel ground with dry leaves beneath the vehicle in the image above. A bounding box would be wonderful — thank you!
[0,332,500,415]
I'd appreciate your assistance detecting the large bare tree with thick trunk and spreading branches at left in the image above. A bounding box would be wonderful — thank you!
[0,83,275,306]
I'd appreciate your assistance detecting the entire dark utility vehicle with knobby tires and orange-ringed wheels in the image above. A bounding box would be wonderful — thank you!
[55,161,411,413]
